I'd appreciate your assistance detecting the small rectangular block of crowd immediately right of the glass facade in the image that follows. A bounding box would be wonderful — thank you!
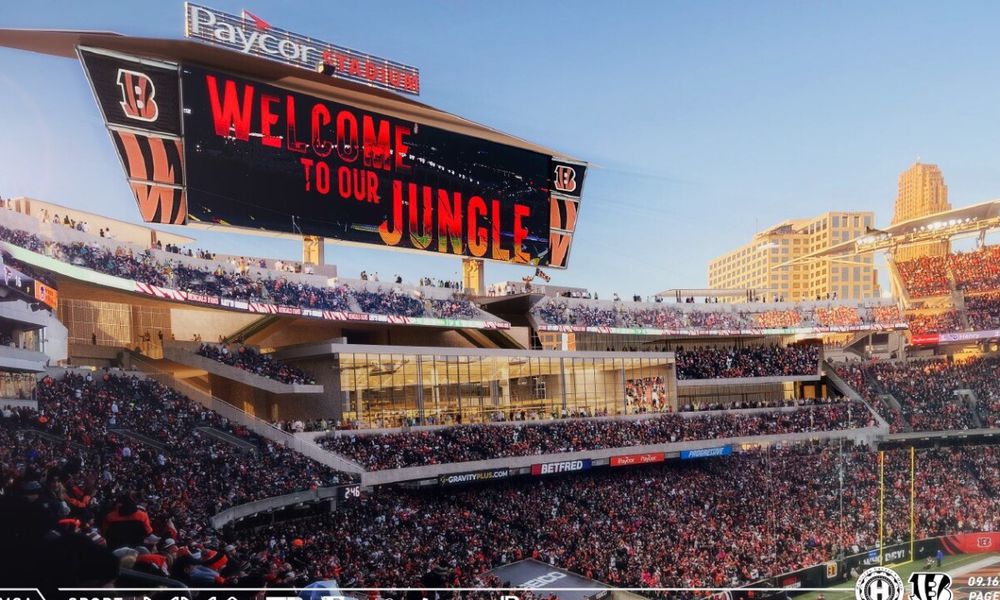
[675,344,820,379]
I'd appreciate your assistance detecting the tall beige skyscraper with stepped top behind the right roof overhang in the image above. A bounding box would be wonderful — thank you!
[892,161,951,262]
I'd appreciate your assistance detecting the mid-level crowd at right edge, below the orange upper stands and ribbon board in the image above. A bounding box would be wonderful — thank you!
[838,357,1000,432]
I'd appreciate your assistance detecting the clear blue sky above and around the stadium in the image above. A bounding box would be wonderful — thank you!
[0,0,1000,297]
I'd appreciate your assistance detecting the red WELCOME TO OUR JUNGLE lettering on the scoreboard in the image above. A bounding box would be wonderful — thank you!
[205,74,532,263]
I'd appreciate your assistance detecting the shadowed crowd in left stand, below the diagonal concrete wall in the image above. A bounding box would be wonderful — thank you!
[0,372,353,585]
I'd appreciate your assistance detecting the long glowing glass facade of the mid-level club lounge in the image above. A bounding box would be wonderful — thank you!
[334,348,676,427]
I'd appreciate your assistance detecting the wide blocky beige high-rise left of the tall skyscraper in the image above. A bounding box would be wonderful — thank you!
[708,212,879,301]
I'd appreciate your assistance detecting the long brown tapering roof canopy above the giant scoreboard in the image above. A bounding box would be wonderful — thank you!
[0,29,577,160]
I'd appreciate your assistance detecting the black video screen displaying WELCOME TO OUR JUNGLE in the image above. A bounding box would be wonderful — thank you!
[181,65,555,265]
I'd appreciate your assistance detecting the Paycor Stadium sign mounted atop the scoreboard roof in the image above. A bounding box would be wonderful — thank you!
[184,2,420,95]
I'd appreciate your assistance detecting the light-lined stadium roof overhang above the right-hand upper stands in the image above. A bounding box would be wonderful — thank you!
[778,200,1000,268]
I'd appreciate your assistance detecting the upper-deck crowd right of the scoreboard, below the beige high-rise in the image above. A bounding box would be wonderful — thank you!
[532,297,903,331]
